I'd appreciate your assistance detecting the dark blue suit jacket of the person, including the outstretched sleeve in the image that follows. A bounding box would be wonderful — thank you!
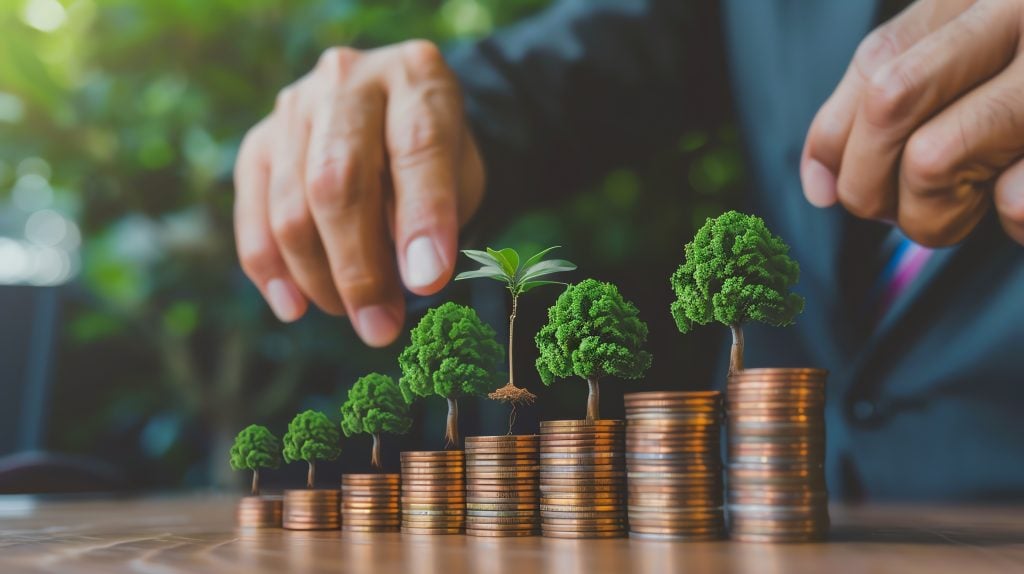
[450,0,1024,499]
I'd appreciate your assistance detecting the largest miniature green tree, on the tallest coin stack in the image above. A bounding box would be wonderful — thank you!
[670,211,804,373]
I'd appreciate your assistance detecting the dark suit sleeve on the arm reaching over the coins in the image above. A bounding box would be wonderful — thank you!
[447,0,721,219]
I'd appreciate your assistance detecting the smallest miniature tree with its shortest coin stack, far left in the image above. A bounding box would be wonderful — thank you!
[229,425,281,528]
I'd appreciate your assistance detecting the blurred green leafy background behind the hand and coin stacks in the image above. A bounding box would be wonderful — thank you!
[0,0,742,488]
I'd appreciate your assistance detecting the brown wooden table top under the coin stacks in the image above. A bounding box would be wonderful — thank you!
[0,495,1024,574]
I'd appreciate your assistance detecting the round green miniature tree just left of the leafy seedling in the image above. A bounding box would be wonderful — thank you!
[398,302,504,447]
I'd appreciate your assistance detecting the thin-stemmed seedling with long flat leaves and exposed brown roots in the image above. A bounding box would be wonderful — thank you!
[455,246,577,435]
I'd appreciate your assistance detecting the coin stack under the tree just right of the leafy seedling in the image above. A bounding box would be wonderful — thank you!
[541,421,626,538]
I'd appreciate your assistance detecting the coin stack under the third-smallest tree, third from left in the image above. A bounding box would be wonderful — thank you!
[341,474,401,532]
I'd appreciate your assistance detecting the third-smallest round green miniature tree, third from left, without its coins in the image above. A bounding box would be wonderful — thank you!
[341,372,413,469]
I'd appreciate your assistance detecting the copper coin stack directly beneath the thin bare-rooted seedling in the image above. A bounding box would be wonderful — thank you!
[466,435,540,536]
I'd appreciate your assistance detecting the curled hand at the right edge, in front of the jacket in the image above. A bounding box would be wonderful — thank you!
[801,0,1024,247]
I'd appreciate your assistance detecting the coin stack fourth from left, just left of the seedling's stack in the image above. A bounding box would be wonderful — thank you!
[401,450,466,534]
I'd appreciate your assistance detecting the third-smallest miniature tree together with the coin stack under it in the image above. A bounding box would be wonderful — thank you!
[341,372,413,532]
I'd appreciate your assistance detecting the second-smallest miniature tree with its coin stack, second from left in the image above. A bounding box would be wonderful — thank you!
[282,410,341,530]
